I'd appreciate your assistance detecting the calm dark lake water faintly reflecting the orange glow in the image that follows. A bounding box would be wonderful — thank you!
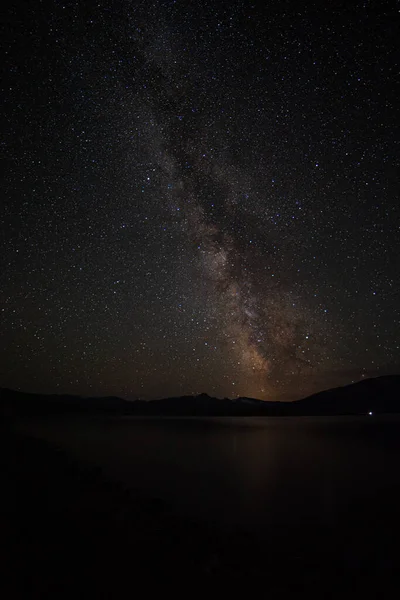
[20,417,400,531]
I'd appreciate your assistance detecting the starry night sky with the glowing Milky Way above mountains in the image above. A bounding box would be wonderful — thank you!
[0,0,400,400]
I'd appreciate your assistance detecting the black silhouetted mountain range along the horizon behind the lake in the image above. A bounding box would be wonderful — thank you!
[0,375,400,417]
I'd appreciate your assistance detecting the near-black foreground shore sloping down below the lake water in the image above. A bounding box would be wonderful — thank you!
[0,426,400,599]
